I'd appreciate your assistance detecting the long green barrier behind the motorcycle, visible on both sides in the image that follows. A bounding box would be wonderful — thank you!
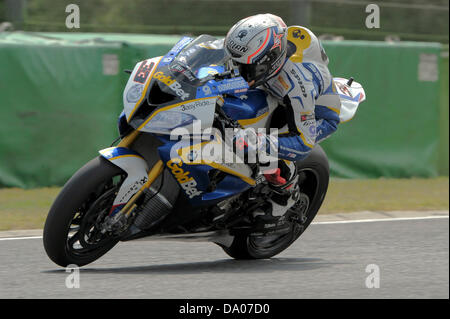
[0,32,448,188]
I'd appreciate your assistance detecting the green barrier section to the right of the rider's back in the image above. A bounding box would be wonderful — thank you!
[324,41,448,178]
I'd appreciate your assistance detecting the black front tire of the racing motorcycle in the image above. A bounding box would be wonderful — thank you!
[43,156,125,267]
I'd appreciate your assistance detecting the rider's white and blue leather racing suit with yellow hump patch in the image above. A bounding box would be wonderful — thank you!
[264,26,341,161]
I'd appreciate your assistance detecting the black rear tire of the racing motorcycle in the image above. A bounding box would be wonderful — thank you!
[221,145,330,259]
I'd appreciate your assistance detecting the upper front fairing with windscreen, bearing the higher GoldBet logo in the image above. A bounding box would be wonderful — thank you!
[123,36,248,134]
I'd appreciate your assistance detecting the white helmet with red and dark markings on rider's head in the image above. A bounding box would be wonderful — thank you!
[224,13,287,87]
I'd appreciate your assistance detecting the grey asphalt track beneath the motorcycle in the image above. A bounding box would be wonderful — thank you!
[0,216,449,299]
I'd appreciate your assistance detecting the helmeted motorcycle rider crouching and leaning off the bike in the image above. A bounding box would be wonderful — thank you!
[224,14,341,218]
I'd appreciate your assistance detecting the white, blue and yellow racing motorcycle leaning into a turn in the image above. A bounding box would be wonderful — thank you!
[43,35,365,267]
